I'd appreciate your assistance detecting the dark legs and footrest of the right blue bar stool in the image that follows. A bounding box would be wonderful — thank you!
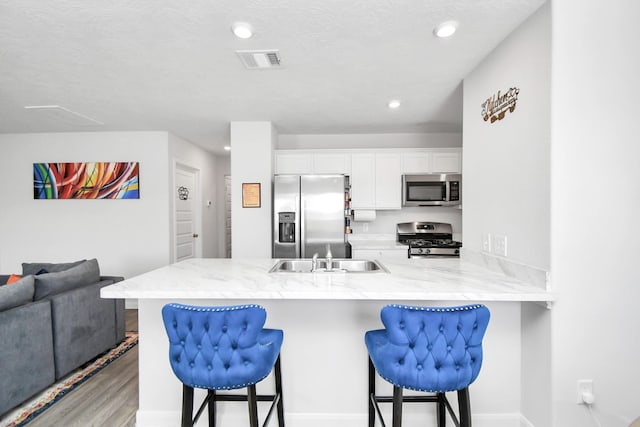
[368,358,471,427]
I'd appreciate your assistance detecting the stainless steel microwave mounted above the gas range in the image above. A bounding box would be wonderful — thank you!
[402,174,462,206]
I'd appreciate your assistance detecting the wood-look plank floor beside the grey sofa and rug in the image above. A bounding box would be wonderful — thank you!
[28,310,138,427]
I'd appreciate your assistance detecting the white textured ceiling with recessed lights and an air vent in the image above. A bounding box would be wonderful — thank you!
[0,0,544,153]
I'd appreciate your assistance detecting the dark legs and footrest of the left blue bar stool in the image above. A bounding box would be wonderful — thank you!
[181,356,285,427]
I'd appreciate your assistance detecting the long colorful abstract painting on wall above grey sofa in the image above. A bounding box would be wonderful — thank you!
[33,162,140,199]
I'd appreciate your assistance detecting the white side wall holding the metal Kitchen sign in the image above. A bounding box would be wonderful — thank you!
[462,2,550,270]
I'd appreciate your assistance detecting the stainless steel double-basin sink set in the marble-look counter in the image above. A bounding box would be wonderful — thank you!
[269,258,389,273]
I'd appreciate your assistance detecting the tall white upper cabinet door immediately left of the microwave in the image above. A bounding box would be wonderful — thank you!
[375,153,402,209]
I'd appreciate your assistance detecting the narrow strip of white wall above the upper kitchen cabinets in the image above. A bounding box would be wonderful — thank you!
[275,132,462,150]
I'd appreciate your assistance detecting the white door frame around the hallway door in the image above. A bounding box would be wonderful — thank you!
[169,159,203,264]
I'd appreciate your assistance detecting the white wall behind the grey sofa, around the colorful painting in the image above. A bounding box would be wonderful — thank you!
[0,132,169,277]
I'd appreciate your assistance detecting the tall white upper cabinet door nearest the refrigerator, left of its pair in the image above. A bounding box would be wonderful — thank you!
[351,153,376,209]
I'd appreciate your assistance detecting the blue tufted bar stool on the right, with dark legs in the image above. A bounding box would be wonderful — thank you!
[365,304,489,427]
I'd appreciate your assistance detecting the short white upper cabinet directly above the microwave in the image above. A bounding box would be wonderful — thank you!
[402,148,462,174]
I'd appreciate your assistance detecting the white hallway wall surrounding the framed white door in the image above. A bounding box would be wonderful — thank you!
[169,134,224,258]
